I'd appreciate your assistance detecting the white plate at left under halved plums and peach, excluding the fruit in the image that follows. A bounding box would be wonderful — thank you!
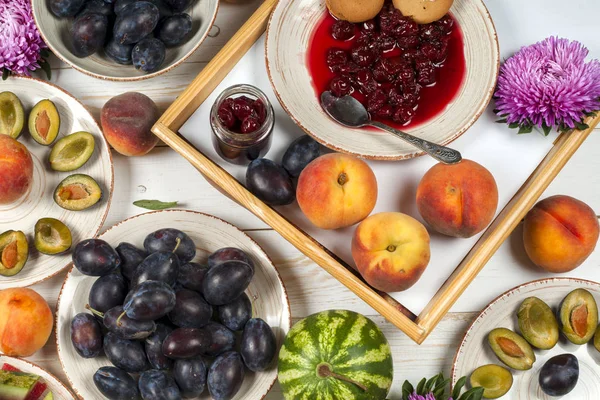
[0,77,113,289]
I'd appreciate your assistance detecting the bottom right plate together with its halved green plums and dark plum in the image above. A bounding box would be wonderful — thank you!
[452,278,600,400]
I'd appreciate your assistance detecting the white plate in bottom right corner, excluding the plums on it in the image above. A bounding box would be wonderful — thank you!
[452,278,600,400]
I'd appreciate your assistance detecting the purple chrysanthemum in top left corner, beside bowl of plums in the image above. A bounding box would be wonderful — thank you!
[0,0,47,75]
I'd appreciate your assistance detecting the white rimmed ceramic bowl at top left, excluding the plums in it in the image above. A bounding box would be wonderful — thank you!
[31,0,219,81]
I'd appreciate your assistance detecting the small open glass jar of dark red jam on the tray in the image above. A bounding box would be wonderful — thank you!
[210,85,275,165]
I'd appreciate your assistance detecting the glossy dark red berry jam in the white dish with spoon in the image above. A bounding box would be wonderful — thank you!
[308,4,466,127]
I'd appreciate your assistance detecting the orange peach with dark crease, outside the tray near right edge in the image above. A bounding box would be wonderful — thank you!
[523,196,600,273]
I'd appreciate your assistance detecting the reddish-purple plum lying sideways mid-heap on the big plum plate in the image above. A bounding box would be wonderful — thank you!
[163,328,212,360]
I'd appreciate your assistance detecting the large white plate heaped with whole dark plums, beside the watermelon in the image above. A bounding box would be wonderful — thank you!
[56,210,291,400]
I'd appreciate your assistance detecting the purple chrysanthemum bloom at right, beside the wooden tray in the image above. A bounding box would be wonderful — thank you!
[495,37,600,131]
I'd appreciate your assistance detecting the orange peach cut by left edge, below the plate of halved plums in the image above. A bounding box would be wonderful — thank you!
[0,288,54,357]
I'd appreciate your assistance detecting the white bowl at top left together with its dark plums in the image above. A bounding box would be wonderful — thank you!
[32,0,219,81]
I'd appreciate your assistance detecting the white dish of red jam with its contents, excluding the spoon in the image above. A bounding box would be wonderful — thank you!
[266,0,499,160]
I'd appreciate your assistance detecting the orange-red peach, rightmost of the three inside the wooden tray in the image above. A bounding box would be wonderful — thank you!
[417,160,498,238]
